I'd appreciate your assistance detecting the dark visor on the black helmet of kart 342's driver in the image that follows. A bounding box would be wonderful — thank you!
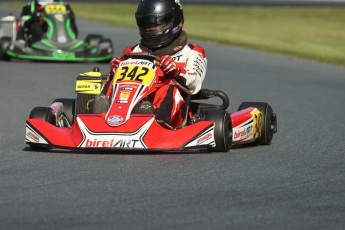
[135,11,173,29]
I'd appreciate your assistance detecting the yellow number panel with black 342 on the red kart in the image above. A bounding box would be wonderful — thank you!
[114,65,155,85]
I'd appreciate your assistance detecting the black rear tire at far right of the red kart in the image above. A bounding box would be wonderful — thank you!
[238,102,277,145]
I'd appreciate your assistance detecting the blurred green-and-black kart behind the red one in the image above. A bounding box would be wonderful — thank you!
[0,3,113,62]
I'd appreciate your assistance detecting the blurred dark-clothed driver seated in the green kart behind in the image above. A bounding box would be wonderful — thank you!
[17,0,78,45]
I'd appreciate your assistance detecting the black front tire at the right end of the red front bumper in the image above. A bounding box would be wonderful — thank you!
[206,110,232,152]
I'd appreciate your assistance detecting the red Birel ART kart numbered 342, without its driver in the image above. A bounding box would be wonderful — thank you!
[25,53,277,152]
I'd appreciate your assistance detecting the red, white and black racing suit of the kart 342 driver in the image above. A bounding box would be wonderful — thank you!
[102,31,207,127]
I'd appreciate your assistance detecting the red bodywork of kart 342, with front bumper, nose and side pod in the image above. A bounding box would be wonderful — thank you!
[25,54,258,151]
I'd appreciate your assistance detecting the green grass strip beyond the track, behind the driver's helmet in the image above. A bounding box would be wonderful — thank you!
[2,3,345,66]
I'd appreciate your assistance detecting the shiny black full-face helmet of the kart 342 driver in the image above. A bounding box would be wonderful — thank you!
[135,0,183,49]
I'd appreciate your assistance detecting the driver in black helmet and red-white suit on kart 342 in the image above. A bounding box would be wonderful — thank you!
[94,0,207,127]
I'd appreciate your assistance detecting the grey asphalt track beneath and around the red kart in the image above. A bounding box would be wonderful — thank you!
[0,9,345,230]
